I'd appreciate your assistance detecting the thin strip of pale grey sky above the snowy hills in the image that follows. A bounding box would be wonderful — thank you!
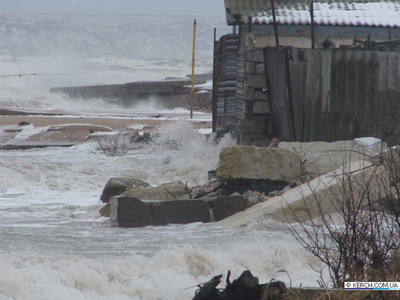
[1,0,224,17]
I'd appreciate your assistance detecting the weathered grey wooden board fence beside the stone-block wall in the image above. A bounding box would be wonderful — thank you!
[265,48,400,142]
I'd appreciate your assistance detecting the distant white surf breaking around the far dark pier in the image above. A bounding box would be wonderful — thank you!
[0,55,209,111]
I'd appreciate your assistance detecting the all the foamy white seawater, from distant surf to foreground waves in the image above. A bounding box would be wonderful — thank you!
[0,51,319,300]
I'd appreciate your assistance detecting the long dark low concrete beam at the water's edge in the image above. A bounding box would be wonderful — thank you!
[110,196,247,227]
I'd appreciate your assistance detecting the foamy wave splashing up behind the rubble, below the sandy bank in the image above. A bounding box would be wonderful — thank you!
[0,121,236,192]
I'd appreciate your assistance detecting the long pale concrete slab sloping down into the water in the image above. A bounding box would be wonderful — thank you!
[207,161,389,228]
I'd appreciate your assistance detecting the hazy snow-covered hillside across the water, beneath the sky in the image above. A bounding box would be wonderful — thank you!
[0,13,229,61]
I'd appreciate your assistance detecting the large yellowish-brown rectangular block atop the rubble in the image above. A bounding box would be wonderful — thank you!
[217,146,301,182]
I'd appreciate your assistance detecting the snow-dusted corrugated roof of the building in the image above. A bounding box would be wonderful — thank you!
[225,0,400,28]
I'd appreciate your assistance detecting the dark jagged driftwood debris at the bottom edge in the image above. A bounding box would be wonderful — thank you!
[193,271,287,300]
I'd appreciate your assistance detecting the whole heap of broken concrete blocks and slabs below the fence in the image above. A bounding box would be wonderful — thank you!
[102,140,389,228]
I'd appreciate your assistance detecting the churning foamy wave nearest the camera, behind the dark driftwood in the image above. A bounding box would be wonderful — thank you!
[0,234,318,300]
